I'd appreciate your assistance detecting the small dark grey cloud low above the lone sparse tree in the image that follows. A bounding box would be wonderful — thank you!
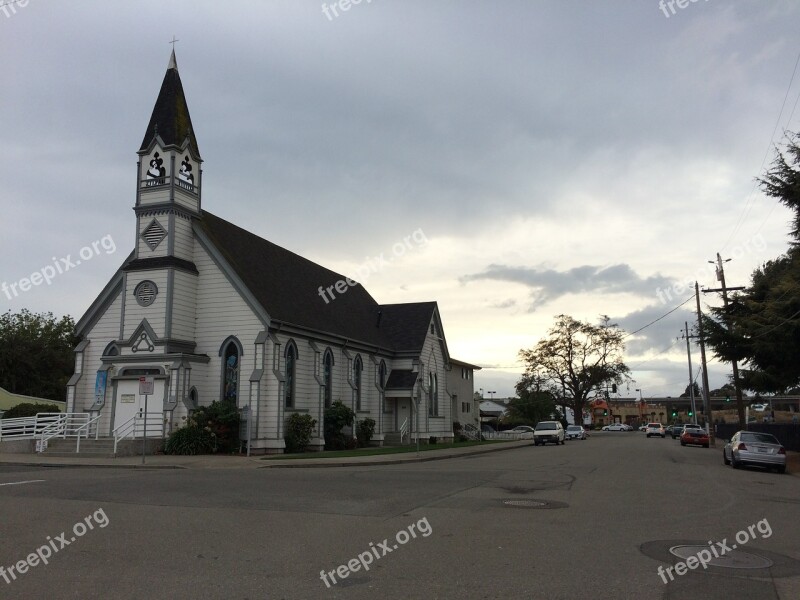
[459,263,672,312]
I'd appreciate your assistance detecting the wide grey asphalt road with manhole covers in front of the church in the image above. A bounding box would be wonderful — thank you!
[0,432,800,600]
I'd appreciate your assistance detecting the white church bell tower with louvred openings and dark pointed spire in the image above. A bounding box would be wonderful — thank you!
[119,49,202,360]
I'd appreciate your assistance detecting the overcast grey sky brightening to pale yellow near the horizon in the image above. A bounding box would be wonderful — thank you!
[0,0,800,397]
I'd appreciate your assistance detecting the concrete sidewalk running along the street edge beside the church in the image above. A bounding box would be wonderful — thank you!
[0,440,533,469]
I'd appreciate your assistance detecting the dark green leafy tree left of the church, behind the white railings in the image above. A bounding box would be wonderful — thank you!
[0,309,79,401]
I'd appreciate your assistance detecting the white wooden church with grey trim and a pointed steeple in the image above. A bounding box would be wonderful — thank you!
[67,51,479,453]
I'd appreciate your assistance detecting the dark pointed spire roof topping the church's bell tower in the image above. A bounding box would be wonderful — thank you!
[139,50,200,156]
